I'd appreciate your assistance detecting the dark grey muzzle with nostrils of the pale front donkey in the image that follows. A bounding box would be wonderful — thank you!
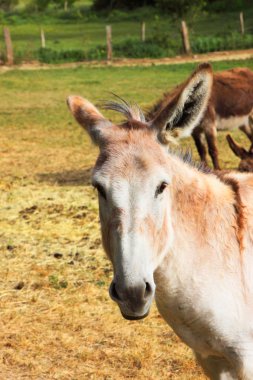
[109,281,155,320]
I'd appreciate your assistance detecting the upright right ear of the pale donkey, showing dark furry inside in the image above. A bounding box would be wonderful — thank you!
[152,63,213,142]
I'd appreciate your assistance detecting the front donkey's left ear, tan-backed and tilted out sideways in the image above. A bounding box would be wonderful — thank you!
[67,95,111,144]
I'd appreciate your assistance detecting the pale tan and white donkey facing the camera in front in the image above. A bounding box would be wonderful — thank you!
[68,64,253,380]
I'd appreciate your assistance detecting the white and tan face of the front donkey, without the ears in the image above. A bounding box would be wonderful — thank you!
[93,129,172,319]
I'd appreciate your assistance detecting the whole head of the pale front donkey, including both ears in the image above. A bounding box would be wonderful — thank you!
[68,64,212,319]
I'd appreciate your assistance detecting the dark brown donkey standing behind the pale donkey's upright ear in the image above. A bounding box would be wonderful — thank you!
[148,68,253,169]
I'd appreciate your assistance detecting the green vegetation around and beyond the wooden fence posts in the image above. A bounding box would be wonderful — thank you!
[0,0,253,63]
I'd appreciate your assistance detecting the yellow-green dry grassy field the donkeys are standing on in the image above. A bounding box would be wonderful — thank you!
[0,60,253,380]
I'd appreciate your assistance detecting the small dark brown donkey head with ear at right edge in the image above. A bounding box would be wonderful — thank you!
[226,135,253,172]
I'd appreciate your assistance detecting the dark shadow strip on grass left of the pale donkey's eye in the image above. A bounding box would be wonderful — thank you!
[37,168,92,186]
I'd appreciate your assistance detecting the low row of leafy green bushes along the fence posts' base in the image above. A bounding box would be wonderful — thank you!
[24,31,253,63]
